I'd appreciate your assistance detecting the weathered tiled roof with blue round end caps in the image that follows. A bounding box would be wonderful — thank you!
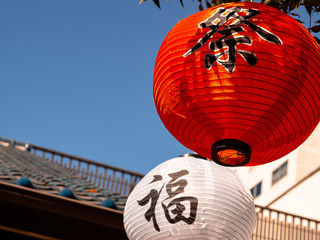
[0,144,127,211]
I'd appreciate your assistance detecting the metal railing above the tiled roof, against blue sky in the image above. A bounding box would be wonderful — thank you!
[28,144,144,196]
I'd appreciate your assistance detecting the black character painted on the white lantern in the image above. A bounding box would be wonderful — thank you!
[138,170,198,232]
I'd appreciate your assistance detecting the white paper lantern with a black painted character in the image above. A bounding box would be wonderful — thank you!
[124,156,256,240]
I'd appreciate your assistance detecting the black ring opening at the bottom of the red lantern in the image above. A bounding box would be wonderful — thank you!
[211,139,252,167]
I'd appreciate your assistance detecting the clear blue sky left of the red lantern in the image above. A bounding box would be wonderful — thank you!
[0,0,318,173]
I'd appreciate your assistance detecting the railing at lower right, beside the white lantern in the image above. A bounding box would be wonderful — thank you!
[251,206,320,240]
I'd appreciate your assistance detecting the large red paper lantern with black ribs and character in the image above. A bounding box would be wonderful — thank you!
[153,2,320,166]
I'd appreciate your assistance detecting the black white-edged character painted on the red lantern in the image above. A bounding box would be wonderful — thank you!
[183,7,282,73]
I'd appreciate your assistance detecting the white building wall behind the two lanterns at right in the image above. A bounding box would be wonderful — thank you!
[235,126,320,219]
